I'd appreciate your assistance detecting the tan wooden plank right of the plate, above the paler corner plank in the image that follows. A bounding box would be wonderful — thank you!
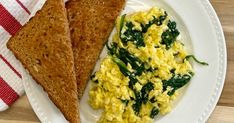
[211,0,234,107]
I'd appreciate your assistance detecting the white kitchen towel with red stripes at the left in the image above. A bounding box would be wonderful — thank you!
[0,0,46,111]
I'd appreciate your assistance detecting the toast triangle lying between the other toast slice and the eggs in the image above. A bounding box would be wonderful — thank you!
[66,0,125,99]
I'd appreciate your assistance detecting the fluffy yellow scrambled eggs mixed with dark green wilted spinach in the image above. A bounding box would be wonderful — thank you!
[89,7,193,123]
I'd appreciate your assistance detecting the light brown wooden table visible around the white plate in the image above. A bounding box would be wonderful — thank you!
[0,0,234,123]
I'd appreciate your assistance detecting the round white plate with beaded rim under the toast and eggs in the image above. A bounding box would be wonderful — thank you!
[23,0,227,123]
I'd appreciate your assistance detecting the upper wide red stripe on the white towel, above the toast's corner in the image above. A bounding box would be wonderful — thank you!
[0,4,22,35]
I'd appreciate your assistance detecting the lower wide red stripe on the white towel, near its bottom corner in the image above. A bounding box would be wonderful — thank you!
[0,77,19,105]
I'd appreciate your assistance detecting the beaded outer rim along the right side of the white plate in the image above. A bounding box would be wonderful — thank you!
[196,0,227,123]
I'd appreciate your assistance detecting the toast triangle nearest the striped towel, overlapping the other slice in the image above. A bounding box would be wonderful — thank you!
[7,0,80,123]
